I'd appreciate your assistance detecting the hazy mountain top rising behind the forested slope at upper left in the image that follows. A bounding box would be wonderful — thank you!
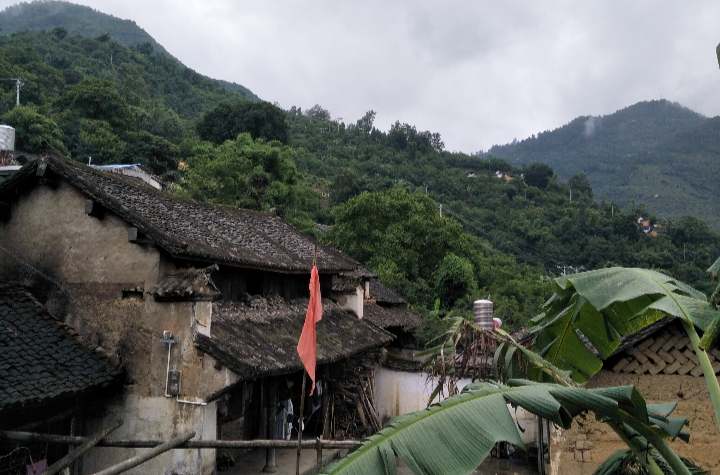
[0,0,259,100]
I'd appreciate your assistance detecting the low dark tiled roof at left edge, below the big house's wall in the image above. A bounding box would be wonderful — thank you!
[0,285,122,410]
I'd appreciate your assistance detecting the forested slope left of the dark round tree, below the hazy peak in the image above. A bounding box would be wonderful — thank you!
[0,27,258,179]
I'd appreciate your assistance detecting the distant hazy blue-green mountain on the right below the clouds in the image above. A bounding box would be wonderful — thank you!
[489,100,720,230]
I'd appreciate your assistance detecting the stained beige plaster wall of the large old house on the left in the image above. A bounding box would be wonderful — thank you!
[0,183,245,475]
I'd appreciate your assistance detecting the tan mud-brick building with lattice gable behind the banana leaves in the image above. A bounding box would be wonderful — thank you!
[550,319,720,475]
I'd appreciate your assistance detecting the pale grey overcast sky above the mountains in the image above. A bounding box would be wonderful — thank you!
[5,0,720,152]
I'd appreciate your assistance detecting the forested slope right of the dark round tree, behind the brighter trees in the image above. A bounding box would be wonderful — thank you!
[280,110,720,300]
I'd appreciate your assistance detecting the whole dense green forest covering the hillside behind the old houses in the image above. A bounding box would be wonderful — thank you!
[0,17,720,338]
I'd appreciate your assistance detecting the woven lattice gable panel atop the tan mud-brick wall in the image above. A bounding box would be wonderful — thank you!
[612,327,720,378]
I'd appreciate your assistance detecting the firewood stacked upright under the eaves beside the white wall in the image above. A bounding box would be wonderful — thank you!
[330,350,382,439]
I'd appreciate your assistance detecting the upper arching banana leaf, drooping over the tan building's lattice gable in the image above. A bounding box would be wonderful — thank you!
[530,267,718,383]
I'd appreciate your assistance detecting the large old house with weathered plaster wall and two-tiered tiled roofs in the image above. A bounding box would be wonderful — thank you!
[0,156,394,474]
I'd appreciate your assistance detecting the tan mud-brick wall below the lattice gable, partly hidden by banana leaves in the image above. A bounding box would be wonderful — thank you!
[551,370,720,475]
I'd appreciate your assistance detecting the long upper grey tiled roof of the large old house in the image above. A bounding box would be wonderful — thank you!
[0,156,360,272]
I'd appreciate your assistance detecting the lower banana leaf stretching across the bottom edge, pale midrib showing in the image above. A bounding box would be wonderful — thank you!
[321,380,688,475]
